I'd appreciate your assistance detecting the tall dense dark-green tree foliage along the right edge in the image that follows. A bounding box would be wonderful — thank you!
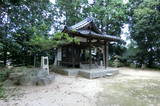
[130,0,160,67]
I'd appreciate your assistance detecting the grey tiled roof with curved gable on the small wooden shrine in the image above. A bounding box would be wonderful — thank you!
[63,17,122,41]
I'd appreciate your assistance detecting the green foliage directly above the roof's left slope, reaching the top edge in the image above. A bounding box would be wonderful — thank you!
[55,0,83,26]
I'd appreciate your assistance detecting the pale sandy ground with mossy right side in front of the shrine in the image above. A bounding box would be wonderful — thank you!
[0,68,160,106]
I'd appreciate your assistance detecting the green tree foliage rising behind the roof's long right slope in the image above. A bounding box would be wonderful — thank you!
[86,0,127,36]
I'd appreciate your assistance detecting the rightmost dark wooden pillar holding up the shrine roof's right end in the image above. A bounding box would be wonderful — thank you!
[104,41,108,68]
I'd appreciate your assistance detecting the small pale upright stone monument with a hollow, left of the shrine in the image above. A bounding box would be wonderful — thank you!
[41,56,49,75]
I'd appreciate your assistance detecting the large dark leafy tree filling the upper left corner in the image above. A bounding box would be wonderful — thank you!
[0,0,54,65]
